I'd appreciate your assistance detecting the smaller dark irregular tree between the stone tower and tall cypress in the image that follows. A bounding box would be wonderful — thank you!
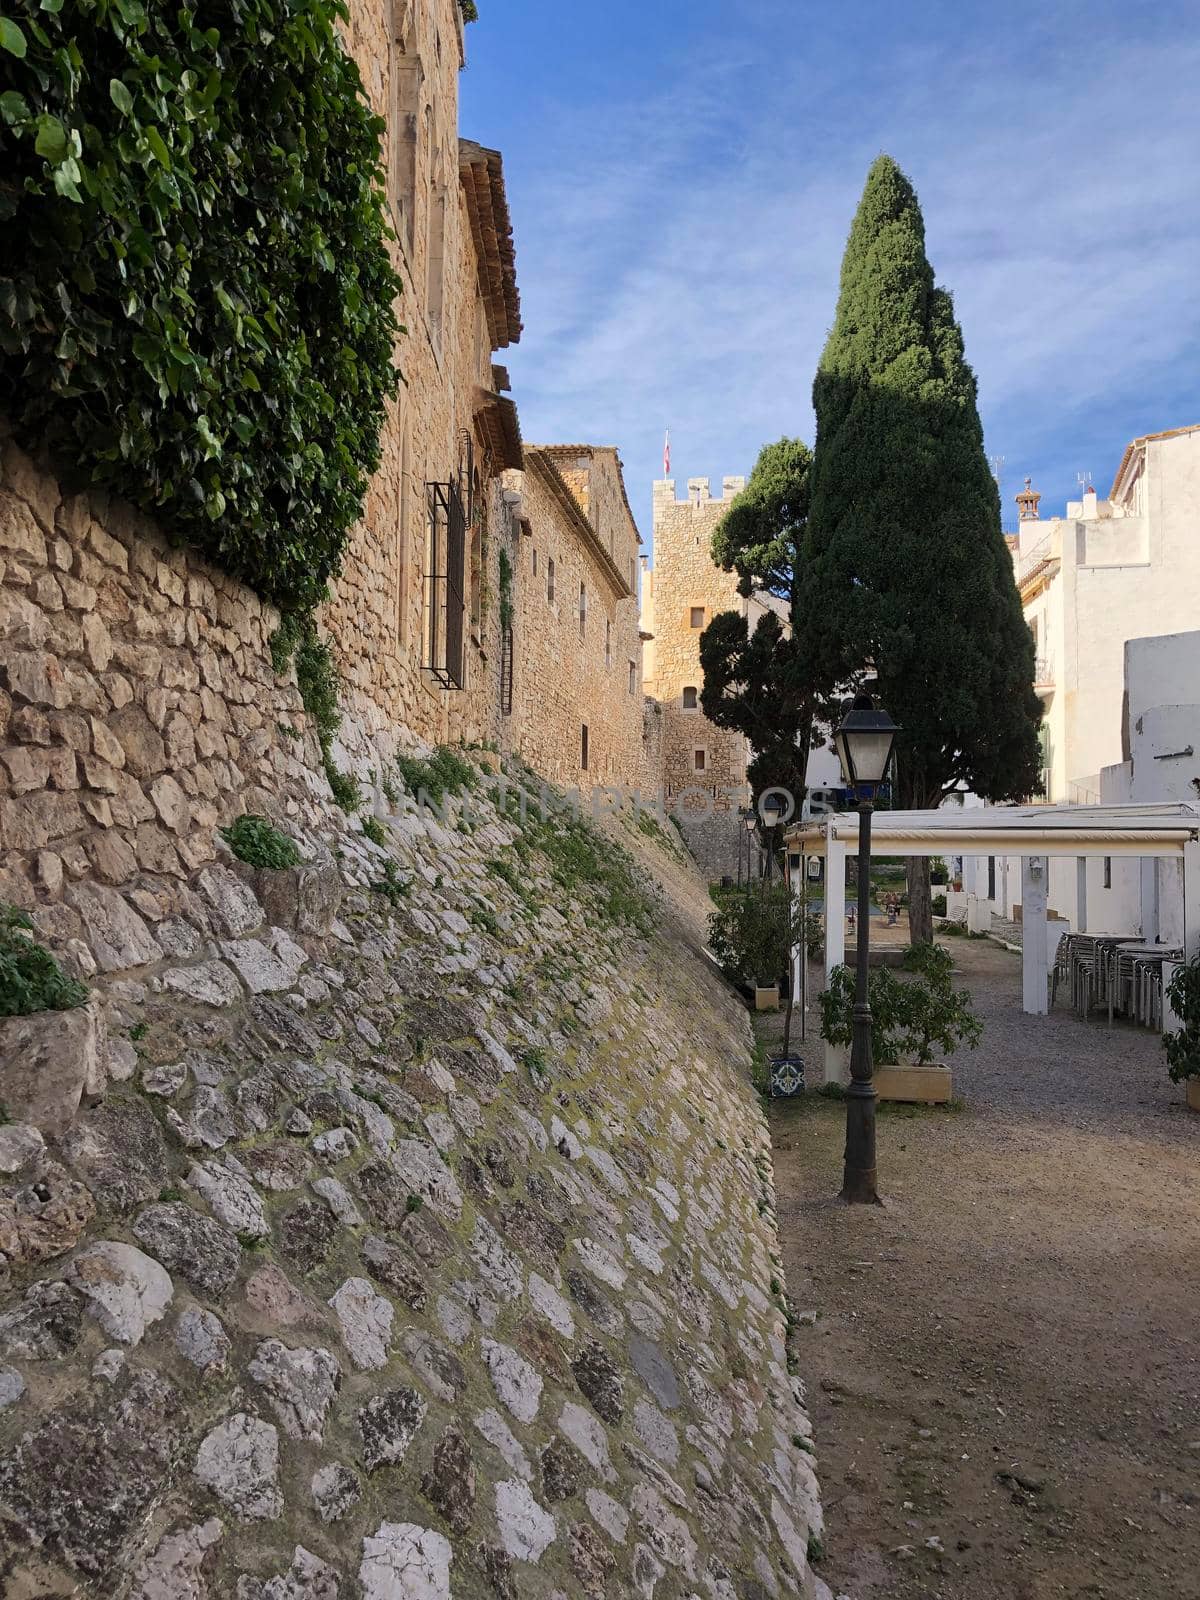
[701,438,813,832]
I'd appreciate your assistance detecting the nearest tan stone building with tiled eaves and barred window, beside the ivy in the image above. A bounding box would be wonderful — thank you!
[322,0,522,755]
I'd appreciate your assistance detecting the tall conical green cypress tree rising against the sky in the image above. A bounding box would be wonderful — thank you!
[798,155,1042,938]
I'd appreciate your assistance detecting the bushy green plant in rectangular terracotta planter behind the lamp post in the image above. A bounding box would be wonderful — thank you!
[819,944,982,1101]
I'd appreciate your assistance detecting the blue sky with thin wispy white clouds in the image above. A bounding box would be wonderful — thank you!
[462,0,1200,539]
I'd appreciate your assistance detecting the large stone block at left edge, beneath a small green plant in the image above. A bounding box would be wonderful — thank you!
[0,1000,106,1138]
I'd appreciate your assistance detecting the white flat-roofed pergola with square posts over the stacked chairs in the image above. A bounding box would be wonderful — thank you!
[787,803,1200,1075]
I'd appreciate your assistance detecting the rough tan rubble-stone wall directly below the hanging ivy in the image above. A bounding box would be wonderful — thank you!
[0,428,328,968]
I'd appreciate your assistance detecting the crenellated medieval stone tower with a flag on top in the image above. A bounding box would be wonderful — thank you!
[642,478,750,878]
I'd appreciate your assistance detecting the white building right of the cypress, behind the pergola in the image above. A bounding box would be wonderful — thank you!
[963,426,1200,931]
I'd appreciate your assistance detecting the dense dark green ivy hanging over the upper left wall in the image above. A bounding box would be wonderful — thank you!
[0,0,402,610]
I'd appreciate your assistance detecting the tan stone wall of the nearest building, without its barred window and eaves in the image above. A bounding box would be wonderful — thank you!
[323,0,515,742]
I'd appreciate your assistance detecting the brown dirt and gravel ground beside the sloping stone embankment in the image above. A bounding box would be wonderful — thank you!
[771,941,1200,1600]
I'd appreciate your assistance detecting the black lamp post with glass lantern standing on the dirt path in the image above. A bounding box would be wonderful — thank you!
[826,694,899,1205]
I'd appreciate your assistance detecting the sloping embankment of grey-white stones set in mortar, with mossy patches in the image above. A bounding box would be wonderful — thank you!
[0,704,827,1600]
